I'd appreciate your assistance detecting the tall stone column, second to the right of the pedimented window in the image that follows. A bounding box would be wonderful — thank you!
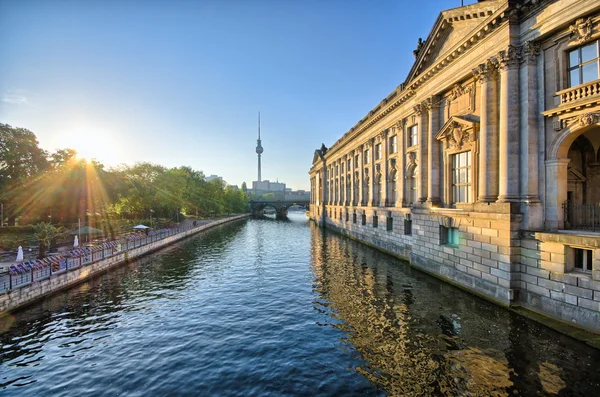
[498,44,519,202]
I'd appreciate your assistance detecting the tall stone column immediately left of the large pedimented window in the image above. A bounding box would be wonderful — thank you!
[424,96,441,206]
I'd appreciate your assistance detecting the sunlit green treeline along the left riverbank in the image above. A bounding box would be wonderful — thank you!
[0,123,248,225]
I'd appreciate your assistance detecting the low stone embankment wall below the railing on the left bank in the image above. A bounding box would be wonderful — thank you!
[0,214,250,313]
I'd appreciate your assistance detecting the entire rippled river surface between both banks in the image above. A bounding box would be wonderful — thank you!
[0,213,600,396]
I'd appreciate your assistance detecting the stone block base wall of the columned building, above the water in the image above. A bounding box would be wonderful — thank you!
[310,206,600,333]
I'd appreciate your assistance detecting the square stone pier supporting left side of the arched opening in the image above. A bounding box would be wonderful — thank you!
[545,159,571,231]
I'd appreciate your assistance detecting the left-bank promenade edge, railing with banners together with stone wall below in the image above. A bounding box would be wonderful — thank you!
[0,214,250,317]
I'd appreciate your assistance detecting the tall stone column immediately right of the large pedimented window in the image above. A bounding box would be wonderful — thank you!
[473,61,499,203]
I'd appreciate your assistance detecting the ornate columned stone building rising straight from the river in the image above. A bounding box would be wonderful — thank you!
[309,0,600,332]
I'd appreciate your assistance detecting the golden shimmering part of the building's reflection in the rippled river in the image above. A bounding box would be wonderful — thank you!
[311,226,512,396]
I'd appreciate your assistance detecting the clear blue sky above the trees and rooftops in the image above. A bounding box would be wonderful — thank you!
[0,0,474,189]
